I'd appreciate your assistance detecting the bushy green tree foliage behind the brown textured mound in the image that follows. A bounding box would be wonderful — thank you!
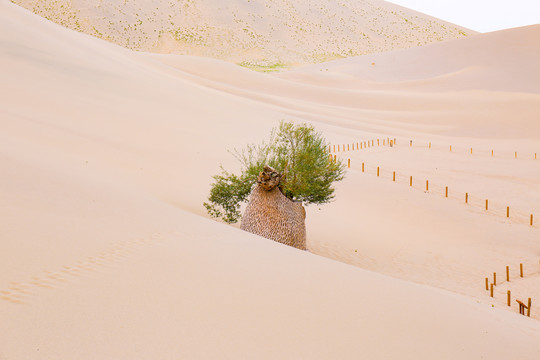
[204,121,345,223]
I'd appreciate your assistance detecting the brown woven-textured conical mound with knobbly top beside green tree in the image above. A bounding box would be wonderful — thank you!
[240,166,306,250]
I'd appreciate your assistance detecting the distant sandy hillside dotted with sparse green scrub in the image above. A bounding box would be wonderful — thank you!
[8,0,475,66]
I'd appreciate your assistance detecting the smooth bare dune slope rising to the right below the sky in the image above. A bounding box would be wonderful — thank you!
[282,25,540,94]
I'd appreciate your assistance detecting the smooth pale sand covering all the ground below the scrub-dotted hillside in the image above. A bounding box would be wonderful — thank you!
[0,0,540,359]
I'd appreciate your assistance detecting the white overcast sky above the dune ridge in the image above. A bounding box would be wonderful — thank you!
[387,0,540,32]
